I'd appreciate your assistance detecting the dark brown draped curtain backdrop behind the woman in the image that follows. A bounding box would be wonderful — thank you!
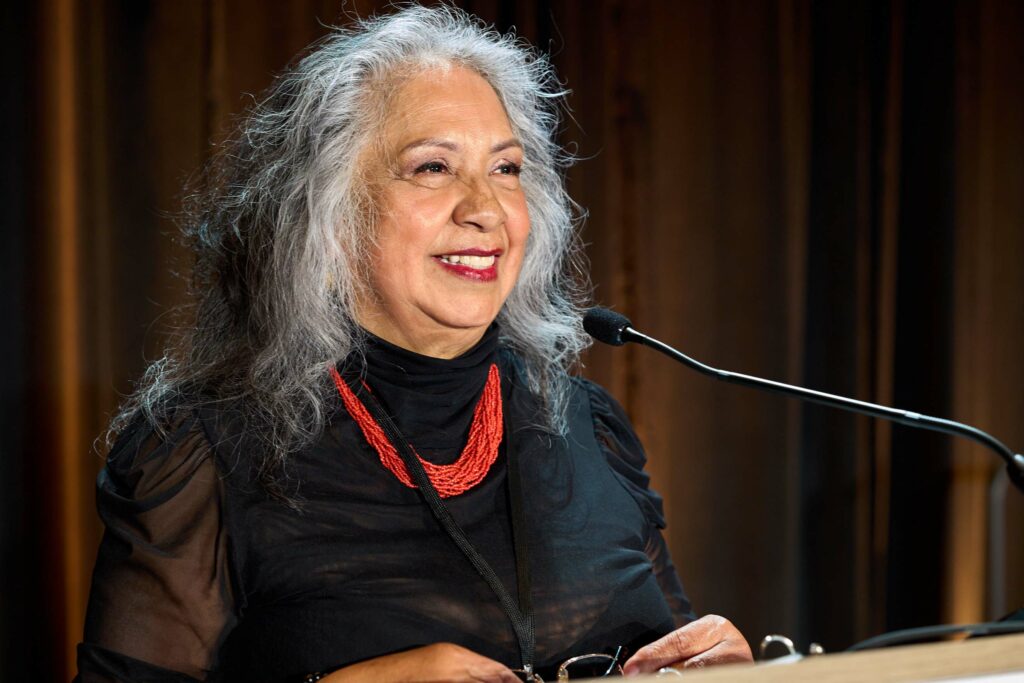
[0,0,1024,681]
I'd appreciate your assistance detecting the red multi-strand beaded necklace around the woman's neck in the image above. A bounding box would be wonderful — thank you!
[331,365,504,498]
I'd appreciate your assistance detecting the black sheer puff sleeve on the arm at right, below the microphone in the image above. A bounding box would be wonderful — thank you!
[584,381,696,626]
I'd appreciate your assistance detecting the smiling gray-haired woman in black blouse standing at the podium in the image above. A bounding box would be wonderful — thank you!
[79,7,750,683]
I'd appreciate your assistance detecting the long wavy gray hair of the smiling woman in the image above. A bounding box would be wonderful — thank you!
[111,6,589,490]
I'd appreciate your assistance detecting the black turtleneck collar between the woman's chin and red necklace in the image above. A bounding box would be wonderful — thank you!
[348,324,499,464]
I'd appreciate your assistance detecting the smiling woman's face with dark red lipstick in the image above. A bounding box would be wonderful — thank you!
[357,67,529,357]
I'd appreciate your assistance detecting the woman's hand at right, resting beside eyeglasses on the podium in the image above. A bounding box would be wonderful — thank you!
[623,614,754,676]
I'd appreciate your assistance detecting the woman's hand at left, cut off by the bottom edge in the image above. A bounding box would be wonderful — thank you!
[321,643,519,683]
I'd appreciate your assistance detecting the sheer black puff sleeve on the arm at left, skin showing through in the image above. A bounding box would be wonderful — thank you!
[78,415,237,683]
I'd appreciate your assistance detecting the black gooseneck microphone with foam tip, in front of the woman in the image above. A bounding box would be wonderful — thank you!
[583,308,1024,493]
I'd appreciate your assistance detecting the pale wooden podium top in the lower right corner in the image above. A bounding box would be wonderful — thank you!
[634,634,1024,683]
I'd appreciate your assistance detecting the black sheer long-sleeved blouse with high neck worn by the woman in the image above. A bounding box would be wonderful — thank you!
[79,329,693,683]
